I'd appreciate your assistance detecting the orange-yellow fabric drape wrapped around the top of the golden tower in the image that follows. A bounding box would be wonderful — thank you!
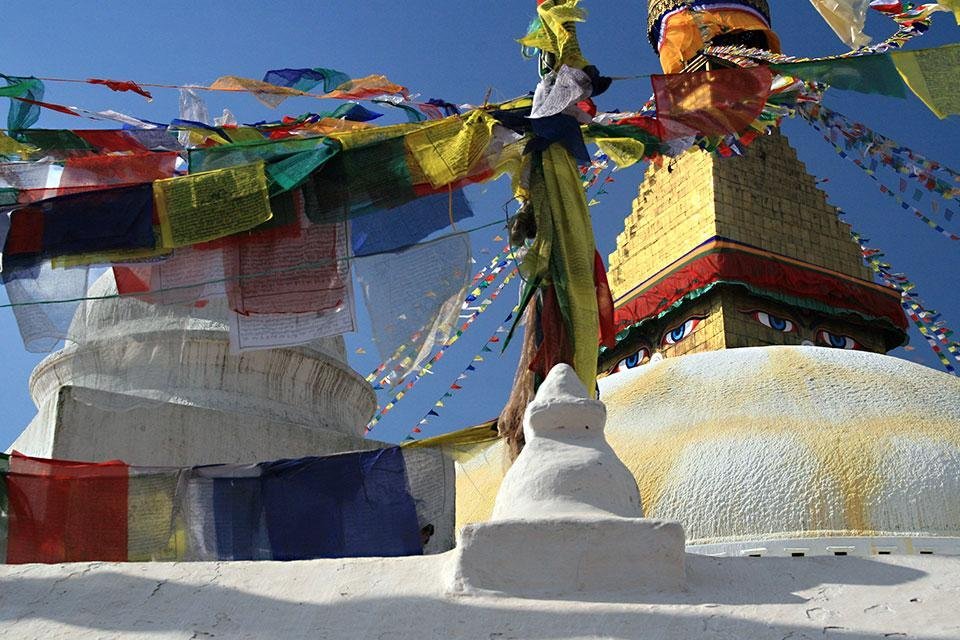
[660,9,780,73]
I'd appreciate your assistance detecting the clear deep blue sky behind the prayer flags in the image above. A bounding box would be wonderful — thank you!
[0,0,960,447]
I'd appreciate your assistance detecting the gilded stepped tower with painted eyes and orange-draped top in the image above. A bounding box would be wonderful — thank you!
[601,0,905,369]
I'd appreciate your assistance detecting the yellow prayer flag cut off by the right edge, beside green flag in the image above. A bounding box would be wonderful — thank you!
[890,44,960,120]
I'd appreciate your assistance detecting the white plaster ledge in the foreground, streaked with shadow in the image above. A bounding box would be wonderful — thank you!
[0,550,960,640]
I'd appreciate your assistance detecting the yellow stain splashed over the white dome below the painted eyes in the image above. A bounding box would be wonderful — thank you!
[603,349,960,536]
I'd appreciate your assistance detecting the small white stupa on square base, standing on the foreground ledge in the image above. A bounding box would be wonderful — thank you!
[447,364,685,596]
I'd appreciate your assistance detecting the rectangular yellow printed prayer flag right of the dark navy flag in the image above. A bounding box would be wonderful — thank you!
[153,161,273,248]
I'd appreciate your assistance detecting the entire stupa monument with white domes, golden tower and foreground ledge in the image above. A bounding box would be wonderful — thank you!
[0,0,960,640]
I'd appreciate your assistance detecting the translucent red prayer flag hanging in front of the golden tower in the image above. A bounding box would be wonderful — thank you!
[651,67,773,140]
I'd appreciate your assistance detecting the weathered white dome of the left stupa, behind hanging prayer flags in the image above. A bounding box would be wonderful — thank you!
[30,270,376,437]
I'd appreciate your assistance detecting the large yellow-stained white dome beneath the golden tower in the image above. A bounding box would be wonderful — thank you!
[600,347,960,555]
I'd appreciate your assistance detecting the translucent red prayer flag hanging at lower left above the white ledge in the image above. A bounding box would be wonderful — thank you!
[7,451,129,564]
